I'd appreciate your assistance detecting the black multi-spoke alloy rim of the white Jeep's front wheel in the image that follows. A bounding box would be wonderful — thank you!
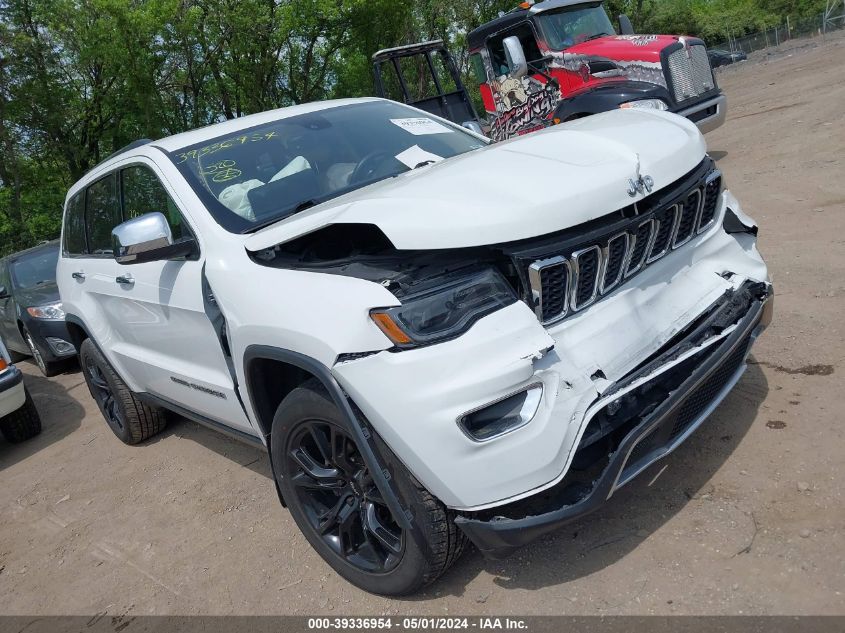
[285,420,405,574]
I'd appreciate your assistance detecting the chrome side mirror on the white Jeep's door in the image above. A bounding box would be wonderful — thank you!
[111,212,196,264]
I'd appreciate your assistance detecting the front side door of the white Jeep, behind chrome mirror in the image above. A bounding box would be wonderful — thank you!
[65,158,255,434]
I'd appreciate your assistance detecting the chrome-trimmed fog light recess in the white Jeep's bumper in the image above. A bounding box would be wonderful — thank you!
[458,384,543,442]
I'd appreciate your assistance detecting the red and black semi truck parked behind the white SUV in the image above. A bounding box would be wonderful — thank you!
[373,0,727,140]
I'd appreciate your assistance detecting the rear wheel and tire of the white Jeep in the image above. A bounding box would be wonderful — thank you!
[79,338,167,444]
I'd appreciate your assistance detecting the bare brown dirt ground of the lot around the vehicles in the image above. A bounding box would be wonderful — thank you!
[0,38,845,616]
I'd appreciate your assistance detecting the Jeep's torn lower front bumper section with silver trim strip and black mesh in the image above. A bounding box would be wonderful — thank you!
[456,282,773,558]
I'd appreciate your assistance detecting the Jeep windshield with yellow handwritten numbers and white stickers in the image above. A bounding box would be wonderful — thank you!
[170,101,485,233]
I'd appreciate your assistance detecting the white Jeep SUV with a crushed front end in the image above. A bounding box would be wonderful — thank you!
[58,99,772,594]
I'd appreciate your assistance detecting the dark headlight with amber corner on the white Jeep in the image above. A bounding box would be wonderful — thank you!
[370,269,517,348]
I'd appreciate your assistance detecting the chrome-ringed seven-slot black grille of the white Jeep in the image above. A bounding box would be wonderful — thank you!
[527,171,722,325]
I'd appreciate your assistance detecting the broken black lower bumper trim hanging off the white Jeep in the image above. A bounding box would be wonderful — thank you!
[455,291,773,558]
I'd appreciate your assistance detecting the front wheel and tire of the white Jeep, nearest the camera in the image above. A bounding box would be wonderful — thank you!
[270,381,466,596]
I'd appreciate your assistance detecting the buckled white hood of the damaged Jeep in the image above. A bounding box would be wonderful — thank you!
[246,110,706,251]
